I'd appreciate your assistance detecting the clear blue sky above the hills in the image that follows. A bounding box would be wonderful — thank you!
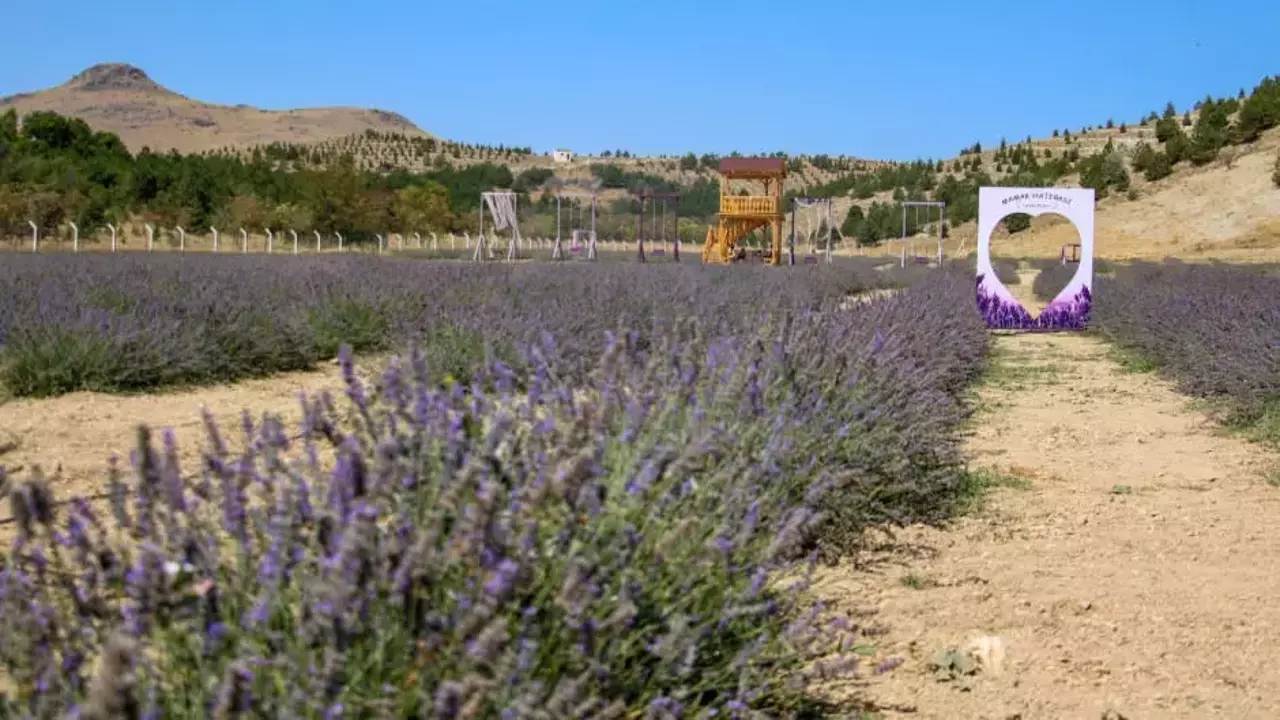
[0,0,1280,160]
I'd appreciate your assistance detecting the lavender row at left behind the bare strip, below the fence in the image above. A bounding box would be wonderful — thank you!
[0,254,892,396]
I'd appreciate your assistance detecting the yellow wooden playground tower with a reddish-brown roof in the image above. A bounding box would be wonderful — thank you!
[703,158,787,265]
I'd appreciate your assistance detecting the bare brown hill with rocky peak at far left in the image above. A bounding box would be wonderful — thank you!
[0,63,428,152]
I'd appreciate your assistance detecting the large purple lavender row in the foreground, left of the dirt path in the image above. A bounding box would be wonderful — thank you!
[0,257,988,719]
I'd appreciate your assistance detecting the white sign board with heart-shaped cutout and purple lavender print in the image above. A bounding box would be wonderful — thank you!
[977,187,1094,331]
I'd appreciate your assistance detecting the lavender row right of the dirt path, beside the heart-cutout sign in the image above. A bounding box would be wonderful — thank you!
[1096,257,1280,439]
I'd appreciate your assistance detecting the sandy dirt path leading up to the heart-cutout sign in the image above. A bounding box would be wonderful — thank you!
[819,334,1280,720]
